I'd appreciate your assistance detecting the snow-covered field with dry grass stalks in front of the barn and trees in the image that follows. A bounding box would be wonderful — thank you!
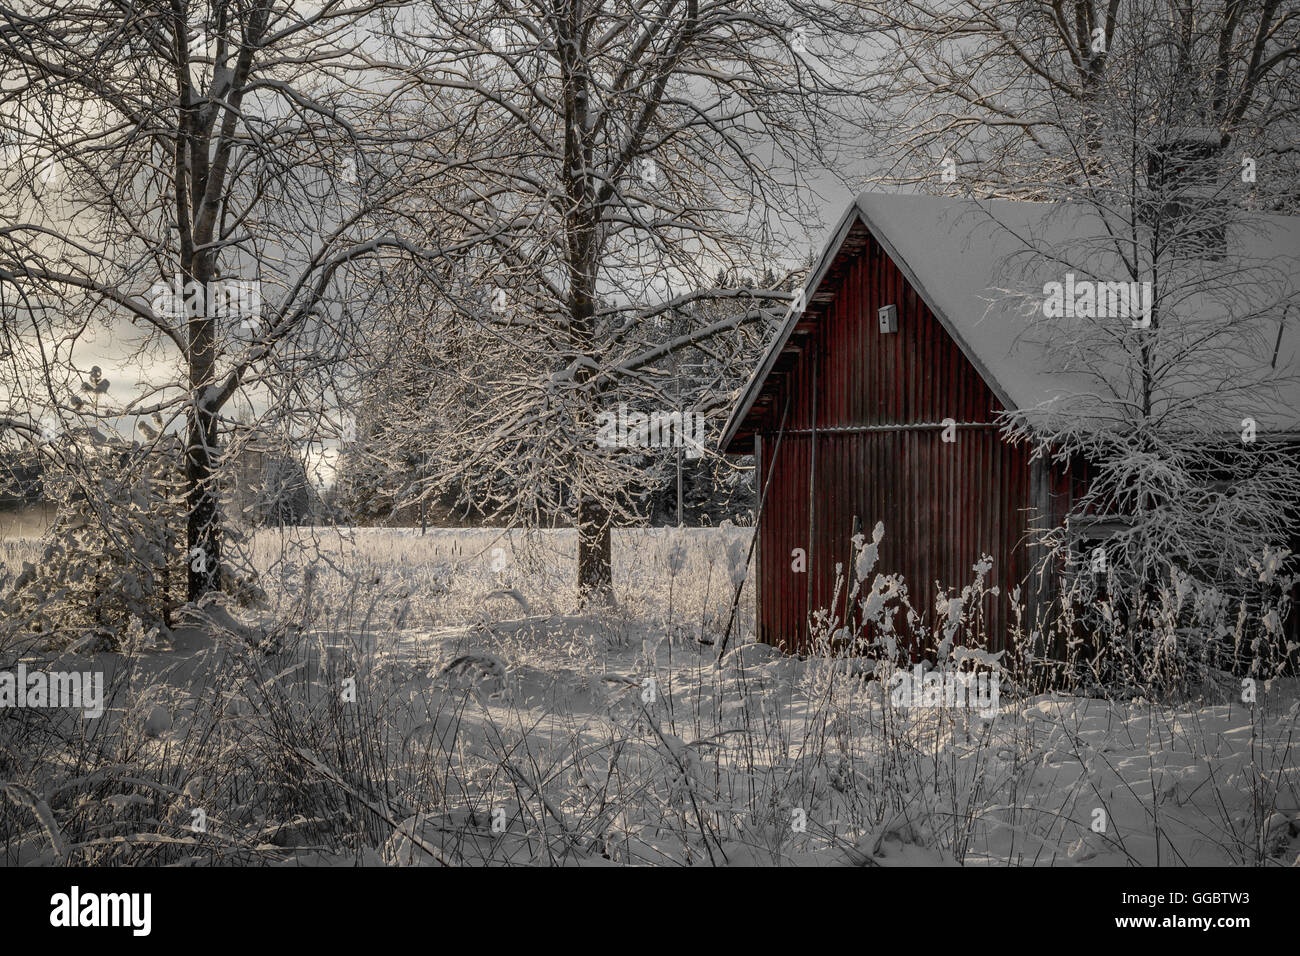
[0,528,1300,866]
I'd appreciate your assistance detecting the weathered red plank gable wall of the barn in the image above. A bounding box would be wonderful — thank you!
[758,230,1034,653]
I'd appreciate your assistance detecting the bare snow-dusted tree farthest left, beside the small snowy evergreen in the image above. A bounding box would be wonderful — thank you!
[0,0,432,600]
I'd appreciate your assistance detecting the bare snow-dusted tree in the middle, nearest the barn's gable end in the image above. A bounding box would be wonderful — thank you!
[379,0,861,601]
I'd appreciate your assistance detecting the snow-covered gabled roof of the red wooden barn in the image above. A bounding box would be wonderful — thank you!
[722,193,1300,451]
